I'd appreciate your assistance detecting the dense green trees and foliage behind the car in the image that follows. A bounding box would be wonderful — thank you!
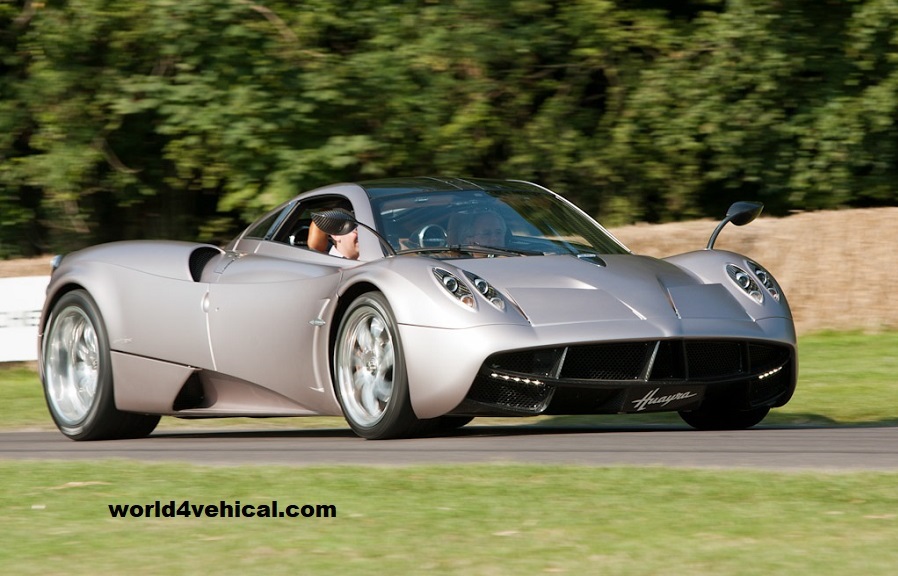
[0,0,898,257]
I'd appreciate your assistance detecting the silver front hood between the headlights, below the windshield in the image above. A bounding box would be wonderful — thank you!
[458,254,751,325]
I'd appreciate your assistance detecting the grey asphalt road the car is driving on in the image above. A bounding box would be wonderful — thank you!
[0,422,898,471]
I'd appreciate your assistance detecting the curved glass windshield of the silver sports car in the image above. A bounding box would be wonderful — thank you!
[373,190,627,258]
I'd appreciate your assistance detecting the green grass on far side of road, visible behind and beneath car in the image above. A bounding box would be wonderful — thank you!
[0,332,898,430]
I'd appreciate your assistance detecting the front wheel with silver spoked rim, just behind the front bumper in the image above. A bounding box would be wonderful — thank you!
[333,292,421,440]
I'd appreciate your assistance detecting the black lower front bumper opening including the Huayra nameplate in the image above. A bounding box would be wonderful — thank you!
[452,340,795,416]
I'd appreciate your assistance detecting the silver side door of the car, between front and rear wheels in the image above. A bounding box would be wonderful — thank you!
[207,197,358,411]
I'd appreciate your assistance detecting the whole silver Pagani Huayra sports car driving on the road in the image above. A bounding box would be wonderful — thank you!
[39,178,797,440]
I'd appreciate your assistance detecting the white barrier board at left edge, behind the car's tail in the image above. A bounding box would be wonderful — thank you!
[0,276,50,362]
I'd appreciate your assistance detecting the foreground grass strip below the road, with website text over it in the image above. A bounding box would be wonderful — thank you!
[0,462,898,576]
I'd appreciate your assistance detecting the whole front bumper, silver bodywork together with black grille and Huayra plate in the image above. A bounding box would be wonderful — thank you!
[400,318,797,418]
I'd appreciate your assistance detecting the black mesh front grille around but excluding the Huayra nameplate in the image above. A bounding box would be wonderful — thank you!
[466,339,794,415]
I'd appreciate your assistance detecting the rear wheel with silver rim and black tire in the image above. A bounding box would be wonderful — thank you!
[41,290,159,440]
